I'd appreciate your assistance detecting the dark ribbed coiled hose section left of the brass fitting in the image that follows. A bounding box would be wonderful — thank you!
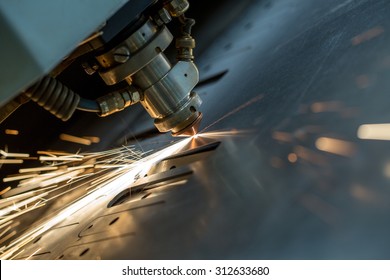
[25,76,80,121]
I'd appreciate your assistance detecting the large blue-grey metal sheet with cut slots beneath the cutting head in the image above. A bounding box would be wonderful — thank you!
[2,0,390,259]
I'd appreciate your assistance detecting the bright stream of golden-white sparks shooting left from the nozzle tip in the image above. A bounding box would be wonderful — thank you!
[0,138,191,259]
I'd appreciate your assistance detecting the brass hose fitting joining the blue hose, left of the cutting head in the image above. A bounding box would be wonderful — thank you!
[97,86,142,117]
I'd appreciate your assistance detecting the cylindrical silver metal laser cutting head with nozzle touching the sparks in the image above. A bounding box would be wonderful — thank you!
[96,0,202,136]
